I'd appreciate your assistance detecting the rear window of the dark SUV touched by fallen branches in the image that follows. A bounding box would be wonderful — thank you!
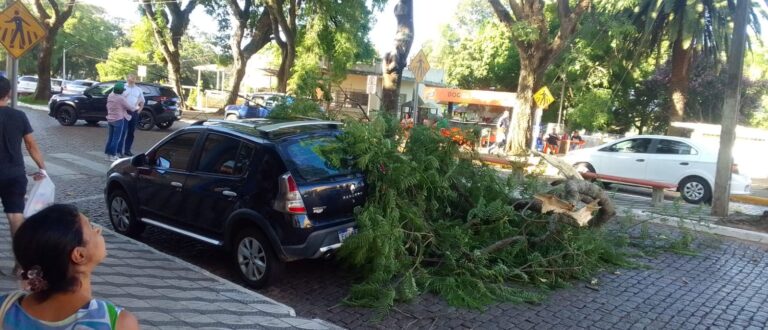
[282,135,352,181]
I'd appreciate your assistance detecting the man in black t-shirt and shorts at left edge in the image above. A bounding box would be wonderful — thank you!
[0,77,45,239]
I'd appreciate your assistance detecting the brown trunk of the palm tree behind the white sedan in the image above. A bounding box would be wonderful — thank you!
[667,37,693,136]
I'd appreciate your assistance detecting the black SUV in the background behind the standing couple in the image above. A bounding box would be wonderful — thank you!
[48,81,181,131]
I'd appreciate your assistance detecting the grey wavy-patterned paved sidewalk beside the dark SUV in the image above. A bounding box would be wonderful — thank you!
[0,214,338,329]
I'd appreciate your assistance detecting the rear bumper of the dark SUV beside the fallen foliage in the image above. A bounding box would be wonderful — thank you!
[282,221,355,261]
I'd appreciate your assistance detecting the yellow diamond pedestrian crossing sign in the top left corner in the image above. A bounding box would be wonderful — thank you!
[0,1,46,58]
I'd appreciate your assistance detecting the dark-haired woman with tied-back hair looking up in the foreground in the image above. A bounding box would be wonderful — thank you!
[0,204,139,329]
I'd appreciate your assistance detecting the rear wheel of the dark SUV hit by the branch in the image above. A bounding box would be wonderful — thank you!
[232,228,283,289]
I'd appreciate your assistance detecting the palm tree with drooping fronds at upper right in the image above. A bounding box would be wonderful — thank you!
[633,0,759,136]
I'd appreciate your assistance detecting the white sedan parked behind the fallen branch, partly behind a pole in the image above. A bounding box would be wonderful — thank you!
[563,135,752,204]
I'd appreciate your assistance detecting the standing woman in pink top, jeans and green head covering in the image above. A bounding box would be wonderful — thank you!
[104,82,133,161]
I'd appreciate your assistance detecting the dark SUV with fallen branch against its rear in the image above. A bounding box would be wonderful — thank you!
[105,119,366,288]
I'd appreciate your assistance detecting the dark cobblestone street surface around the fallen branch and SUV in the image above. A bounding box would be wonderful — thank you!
[16,106,768,329]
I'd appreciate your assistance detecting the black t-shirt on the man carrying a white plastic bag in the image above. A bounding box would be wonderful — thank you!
[0,107,32,179]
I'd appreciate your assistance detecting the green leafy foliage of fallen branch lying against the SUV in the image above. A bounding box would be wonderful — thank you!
[322,118,630,311]
